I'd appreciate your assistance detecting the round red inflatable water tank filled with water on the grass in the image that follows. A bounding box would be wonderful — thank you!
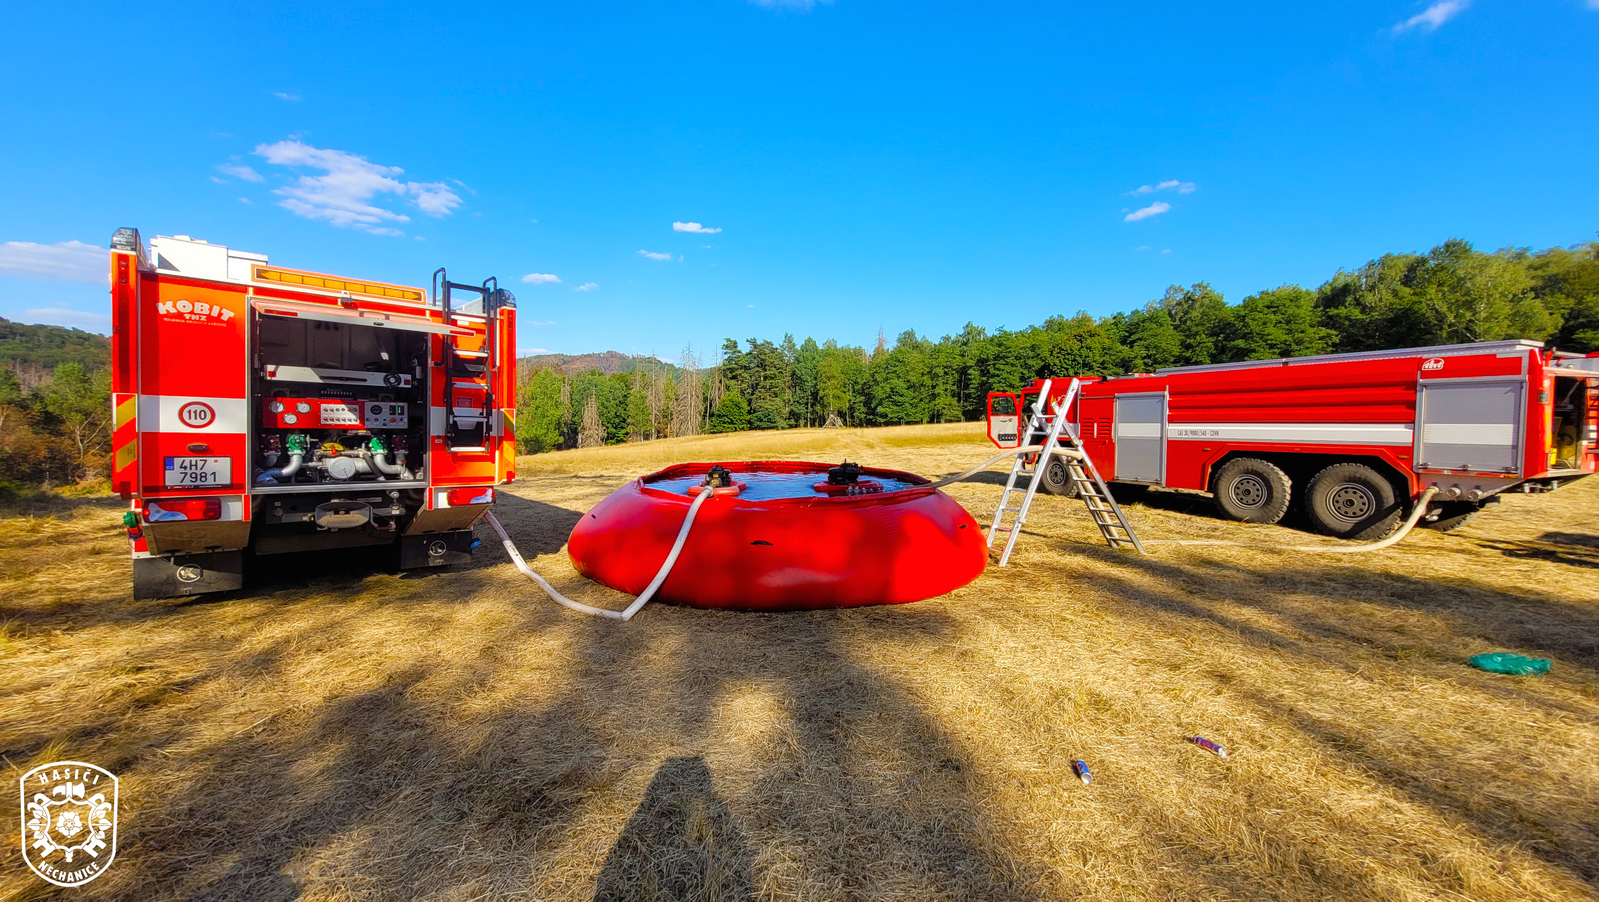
[566,461,988,611]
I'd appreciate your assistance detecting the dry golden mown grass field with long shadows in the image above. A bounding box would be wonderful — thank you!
[0,425,1599,902]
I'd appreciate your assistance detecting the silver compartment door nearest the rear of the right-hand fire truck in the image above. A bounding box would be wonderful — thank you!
[1415,379,1527,475]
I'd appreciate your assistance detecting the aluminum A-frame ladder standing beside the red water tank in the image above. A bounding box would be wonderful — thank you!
[988,379,1145,566]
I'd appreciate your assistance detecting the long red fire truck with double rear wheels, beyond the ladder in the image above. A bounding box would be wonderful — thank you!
[988,341,1599,537]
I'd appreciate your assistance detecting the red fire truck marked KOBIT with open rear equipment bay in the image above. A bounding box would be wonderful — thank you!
[110,229,516,598]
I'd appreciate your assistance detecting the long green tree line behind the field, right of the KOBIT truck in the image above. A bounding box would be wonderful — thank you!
[516,240,1599,454]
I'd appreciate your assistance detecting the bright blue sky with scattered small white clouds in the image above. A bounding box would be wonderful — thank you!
[0,0,1599,358]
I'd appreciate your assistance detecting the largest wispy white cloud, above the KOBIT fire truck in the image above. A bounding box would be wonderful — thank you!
[256,139,461,235]
